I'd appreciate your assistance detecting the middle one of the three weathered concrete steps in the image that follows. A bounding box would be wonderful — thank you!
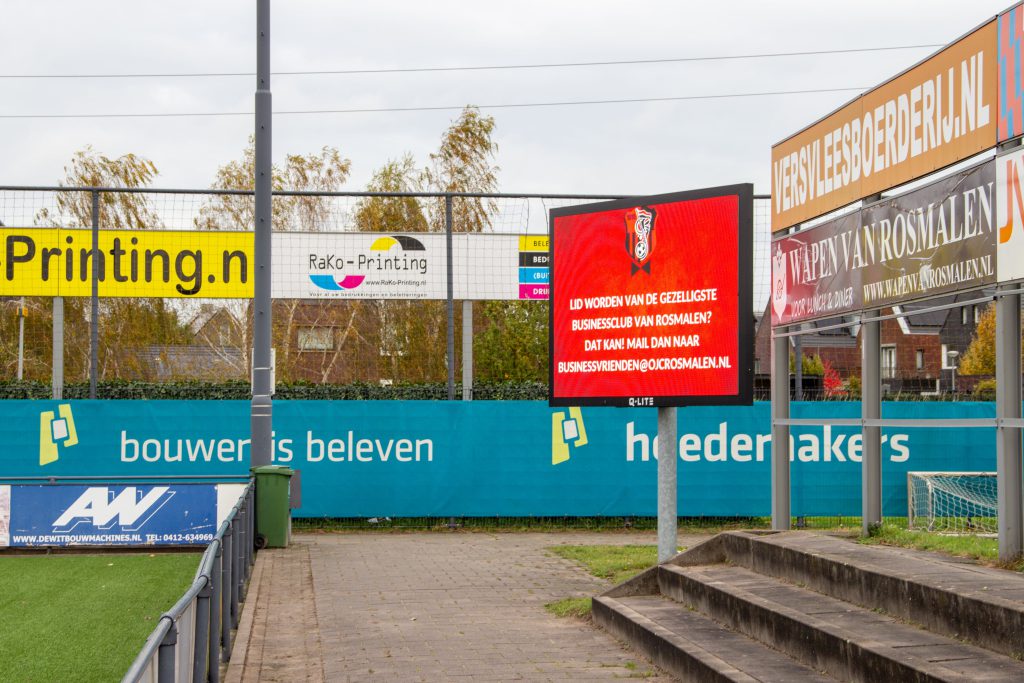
[659,564,1024,683]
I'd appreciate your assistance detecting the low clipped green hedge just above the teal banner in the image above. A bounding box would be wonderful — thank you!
[0,381,548,400]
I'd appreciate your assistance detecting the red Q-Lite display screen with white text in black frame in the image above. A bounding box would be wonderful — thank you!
[550,184,753,407]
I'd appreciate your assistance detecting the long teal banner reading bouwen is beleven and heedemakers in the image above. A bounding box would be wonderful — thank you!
[0,400,995,517]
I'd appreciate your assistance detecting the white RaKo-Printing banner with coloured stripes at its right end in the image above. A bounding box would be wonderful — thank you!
[272,232,548,300]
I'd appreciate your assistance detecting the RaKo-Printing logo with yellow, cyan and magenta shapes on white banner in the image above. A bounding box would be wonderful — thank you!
[309,234,427,292]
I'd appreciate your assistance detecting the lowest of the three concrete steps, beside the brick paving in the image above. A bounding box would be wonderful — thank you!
[593,595,836,683]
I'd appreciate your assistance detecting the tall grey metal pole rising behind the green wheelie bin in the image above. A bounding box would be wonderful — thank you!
[251,0,273,467]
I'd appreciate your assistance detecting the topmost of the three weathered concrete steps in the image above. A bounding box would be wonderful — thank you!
[672,531,1024,658]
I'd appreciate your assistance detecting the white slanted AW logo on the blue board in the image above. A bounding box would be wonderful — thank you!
[53,486,174,533]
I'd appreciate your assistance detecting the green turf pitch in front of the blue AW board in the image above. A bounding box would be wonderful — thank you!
[0,553,201,682]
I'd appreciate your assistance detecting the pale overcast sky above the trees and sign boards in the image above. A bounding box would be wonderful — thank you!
[0,0,1010,200]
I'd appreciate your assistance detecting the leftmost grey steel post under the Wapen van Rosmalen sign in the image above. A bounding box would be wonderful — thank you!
[771,335,791,531]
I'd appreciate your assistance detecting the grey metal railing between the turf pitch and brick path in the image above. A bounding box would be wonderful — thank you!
[122,480,256,683]
